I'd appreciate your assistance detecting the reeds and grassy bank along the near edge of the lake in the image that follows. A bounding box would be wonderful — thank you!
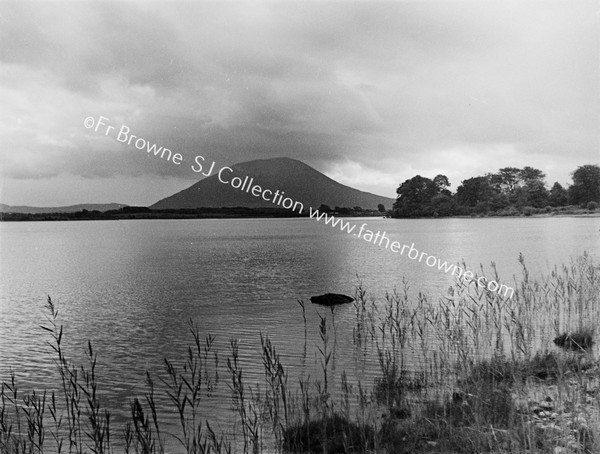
[0,256,600,454]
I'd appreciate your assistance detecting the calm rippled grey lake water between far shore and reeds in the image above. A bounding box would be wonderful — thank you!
[0,217,600,446]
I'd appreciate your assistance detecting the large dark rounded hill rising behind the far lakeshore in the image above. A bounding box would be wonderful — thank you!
[150,158,395,210]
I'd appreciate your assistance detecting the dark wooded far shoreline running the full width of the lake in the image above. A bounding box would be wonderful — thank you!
[0,164,600,221]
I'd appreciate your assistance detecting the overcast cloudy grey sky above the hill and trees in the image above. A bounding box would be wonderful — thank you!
[0,0,600,206]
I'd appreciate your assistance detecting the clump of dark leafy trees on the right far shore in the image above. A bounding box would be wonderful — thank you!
[391,165,600,217]
